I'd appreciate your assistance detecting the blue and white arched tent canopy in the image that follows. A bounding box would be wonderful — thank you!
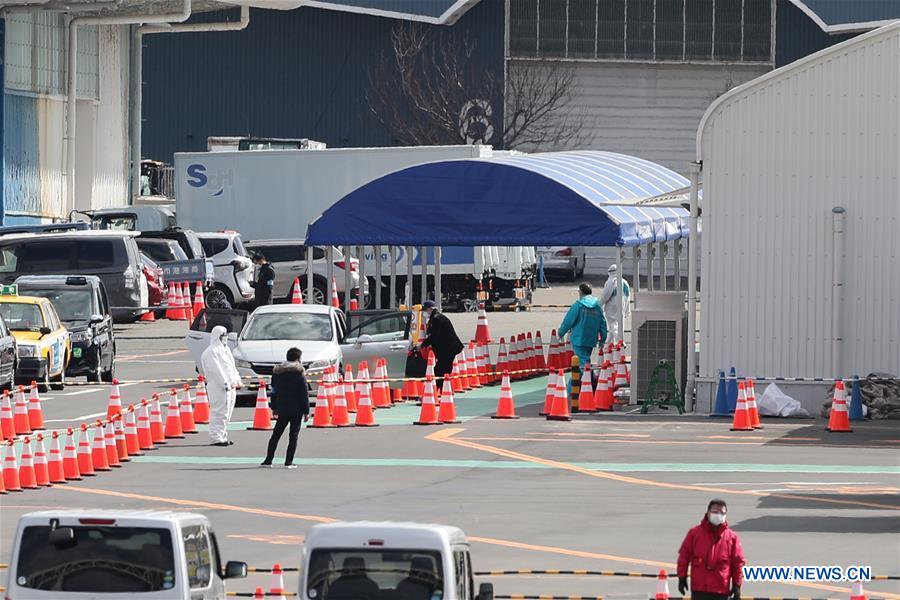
[307,151,689,246]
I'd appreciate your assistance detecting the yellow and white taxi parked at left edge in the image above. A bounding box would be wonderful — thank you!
[0,285,72,390]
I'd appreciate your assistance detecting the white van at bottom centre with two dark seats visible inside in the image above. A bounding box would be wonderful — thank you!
[300,521,494,600]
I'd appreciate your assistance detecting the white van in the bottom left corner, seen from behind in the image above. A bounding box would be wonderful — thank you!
[5,510,247,600]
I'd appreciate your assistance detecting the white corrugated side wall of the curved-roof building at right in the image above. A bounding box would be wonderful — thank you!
[698,24,900,377]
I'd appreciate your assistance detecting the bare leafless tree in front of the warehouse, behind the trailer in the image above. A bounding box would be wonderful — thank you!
[368,23,583,149]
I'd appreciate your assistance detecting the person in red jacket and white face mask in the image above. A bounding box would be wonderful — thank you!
[678,499,744,600]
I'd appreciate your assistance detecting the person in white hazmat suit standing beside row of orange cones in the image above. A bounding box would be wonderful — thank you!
[200,325,241,446]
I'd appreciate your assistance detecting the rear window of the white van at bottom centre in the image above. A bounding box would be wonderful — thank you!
[307,549,444,600]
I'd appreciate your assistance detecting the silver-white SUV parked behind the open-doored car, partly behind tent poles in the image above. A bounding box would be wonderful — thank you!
[245,240,369,304]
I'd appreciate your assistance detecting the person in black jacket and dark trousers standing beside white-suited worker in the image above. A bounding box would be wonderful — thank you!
[260,348,309,469]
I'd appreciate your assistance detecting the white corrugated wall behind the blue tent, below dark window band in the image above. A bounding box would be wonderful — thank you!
[510,60,771,175]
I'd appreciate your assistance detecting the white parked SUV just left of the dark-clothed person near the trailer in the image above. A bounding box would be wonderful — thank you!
[197,231,254,307]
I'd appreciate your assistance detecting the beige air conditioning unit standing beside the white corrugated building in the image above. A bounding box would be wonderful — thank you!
[631,291,688,404]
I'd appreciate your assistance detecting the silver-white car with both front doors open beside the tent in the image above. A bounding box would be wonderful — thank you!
[185,304,413,398]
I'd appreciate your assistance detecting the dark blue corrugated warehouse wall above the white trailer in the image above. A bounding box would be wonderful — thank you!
[143,0,505,161]
